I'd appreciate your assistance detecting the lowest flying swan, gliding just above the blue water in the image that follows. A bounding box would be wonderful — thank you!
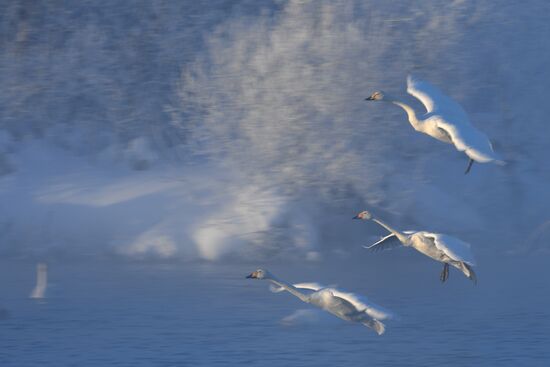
[247,269,392,335]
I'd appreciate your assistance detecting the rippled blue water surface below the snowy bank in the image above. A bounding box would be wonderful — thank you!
[0,256,550,367]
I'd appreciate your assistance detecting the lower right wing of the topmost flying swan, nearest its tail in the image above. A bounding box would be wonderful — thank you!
[434,116,504,163]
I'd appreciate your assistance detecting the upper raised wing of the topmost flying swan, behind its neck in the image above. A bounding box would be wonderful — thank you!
[407,75,466,116]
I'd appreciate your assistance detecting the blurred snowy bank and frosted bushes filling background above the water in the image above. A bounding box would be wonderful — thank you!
[0,0,550,264]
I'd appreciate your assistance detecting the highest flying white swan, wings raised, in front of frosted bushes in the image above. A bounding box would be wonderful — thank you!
[366,76,504,173]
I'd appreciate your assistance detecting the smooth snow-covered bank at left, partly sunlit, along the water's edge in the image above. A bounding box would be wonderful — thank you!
[0,140,324,260]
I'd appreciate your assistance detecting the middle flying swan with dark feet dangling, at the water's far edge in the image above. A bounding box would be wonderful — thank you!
[353,211,477,283]
